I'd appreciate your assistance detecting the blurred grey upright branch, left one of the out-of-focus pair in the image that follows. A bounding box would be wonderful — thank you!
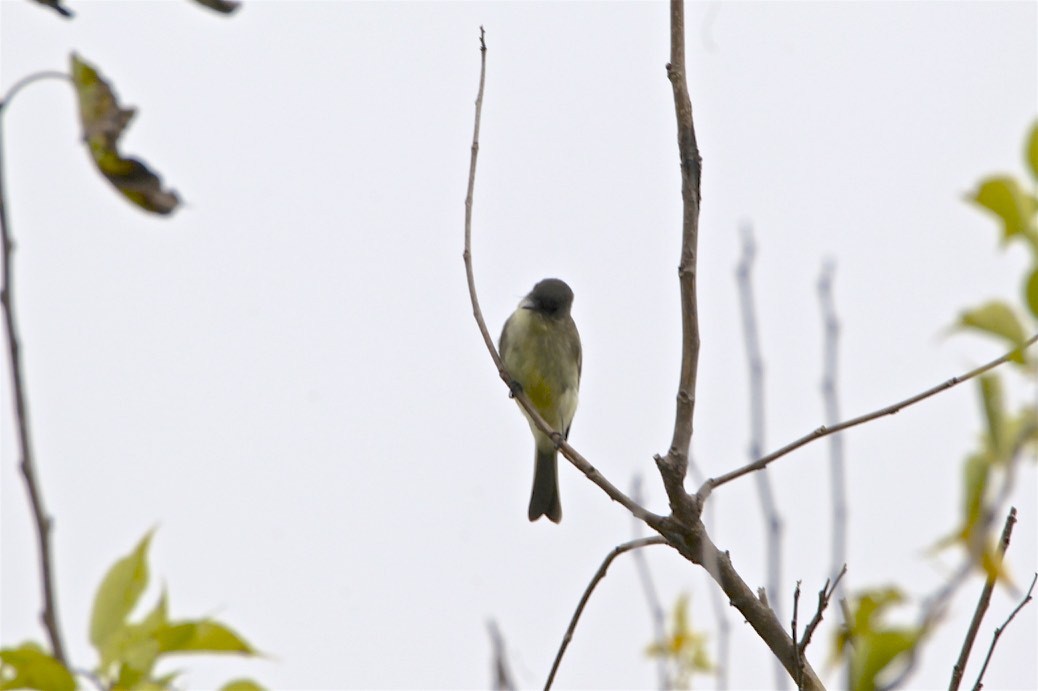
[735,225,795,689]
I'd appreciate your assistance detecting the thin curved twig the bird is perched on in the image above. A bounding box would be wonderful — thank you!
[462,27,663,530]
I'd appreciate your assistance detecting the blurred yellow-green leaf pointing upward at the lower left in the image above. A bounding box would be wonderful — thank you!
[90,530,152,659]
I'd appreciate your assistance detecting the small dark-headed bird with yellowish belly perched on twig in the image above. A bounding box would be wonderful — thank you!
[498,278,581,523]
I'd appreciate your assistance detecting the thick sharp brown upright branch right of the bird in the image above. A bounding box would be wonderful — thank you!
[656,0,703,523]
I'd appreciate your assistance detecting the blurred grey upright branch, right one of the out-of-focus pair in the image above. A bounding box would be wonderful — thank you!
[818,261,847,599]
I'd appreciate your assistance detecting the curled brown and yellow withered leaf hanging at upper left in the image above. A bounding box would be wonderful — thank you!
[72,53,180,214]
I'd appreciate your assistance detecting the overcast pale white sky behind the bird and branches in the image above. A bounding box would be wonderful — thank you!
[0,0,1038,689]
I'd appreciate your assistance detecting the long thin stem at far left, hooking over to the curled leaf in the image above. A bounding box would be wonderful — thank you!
[0,72,69,667]
